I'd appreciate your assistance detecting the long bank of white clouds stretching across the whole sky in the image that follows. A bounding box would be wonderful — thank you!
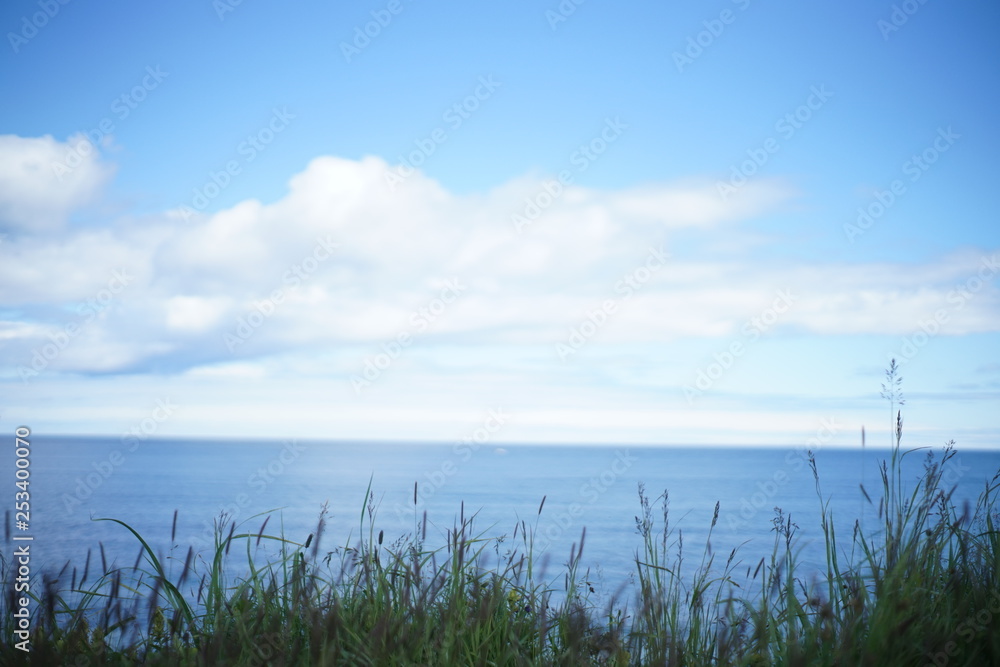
[0,152,1000,377]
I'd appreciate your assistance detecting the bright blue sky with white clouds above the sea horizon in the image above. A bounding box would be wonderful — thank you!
[0,0,1000,448]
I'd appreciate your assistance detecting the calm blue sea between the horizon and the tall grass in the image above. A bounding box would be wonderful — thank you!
[9,435,1000,594]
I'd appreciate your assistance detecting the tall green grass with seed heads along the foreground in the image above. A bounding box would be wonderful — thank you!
[0,368,1000,667]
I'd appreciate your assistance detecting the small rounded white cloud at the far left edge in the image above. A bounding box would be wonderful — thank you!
[0,134,114,232]
